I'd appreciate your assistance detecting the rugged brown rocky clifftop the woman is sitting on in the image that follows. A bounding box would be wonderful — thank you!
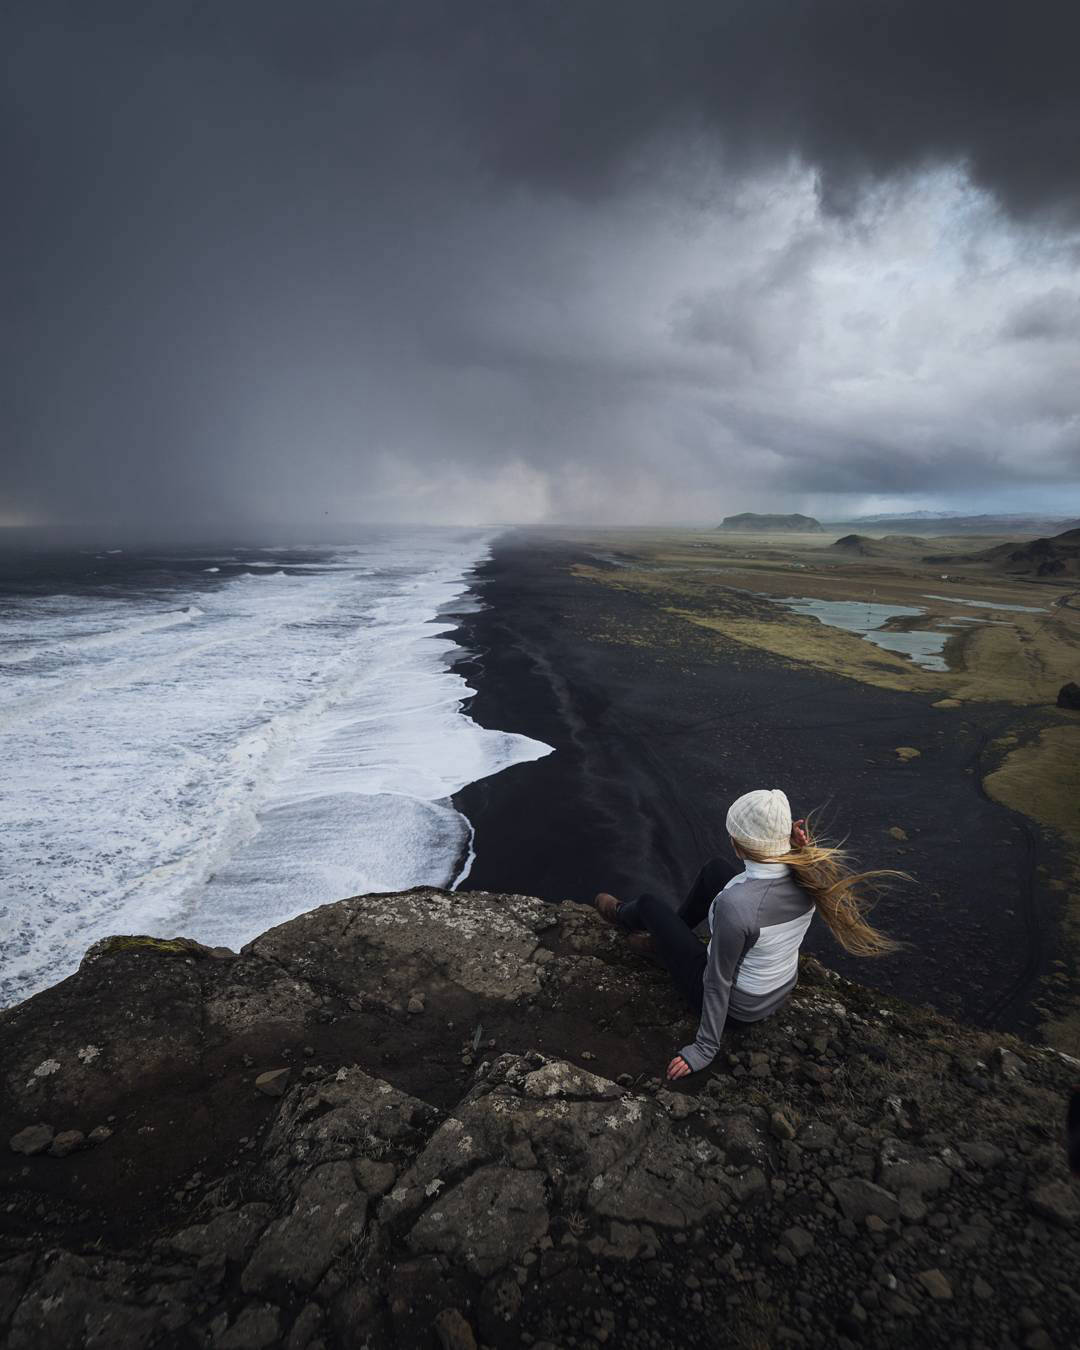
[0,890,1080,1350]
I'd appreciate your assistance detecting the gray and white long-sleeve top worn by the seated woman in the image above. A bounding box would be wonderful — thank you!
[679,859,814,1072]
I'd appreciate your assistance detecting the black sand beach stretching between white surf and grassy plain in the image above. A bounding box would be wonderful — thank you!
[456,531,1053,1030]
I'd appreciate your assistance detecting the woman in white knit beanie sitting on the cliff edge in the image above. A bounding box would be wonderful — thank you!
[593,787,903,1079]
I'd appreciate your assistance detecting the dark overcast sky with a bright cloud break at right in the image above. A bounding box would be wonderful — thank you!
[0,0,1080,525]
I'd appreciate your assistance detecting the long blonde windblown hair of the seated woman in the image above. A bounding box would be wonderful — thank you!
[738,817,911,956]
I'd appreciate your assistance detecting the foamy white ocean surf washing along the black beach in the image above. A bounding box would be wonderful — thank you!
[0,529,551,1004]
